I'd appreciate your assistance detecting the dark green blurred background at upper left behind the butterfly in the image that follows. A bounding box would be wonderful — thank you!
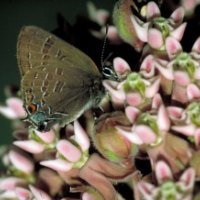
[0,0,116,145]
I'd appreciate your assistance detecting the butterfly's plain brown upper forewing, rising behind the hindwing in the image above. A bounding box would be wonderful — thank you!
[17,26,100,76]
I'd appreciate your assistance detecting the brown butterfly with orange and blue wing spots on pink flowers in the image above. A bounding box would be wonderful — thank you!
[17,26,105,131]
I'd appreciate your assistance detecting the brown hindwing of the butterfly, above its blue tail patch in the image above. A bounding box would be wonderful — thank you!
[21,66,100,123]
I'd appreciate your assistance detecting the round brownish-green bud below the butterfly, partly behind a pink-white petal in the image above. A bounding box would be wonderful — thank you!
[93,112,137,162]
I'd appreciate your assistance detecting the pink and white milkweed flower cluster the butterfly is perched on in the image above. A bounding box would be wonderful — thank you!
[0,0,200,200]
